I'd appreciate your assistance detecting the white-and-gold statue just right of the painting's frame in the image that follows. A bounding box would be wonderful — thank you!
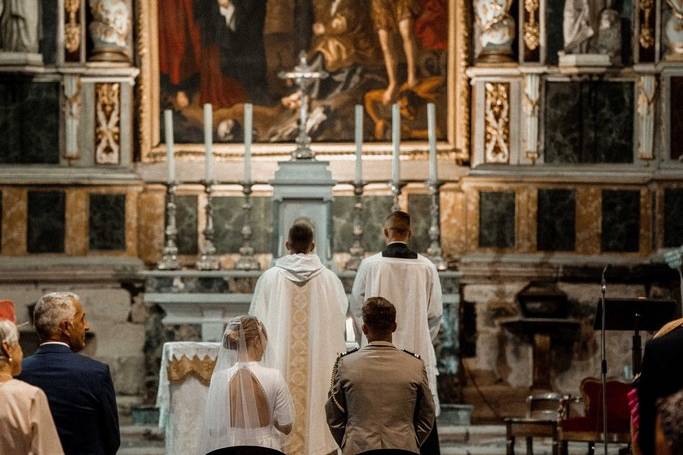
[474,0,515,62]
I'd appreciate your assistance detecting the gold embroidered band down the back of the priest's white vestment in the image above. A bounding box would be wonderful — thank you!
[285,286,310,455]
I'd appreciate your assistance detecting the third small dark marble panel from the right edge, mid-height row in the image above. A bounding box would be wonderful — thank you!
[536,189,576,251]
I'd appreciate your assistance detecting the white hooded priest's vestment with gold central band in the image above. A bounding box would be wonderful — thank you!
[249,254,348,455]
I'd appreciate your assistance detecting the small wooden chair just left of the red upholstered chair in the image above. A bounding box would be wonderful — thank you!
[505,392,566,455]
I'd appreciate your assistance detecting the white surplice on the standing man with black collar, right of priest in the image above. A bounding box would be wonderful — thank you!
[351,253,443,415]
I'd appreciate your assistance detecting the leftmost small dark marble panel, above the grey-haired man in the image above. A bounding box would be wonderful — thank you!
[26,191,66,253]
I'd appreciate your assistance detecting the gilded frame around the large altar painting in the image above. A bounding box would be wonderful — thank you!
[135,0,472,163]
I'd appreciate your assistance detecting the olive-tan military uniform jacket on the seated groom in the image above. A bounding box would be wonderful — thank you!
[325,341,434,455]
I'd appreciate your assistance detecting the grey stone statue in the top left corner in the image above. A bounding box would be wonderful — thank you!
[0,0,41,54]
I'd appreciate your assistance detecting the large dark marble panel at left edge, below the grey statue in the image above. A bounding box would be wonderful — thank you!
[0,81,60,164]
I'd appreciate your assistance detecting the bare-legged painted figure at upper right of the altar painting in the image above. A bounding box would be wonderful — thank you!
[371,0,421,104]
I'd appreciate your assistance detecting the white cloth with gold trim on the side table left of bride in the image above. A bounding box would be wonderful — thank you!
[157,341,220,455]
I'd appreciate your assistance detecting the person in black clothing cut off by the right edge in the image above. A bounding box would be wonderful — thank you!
[638,320,683,455]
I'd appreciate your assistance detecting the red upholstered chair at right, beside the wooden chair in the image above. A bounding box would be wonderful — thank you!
[559,378,631,455]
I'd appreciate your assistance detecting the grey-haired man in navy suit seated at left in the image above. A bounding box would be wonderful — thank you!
[19,292,120,455]
